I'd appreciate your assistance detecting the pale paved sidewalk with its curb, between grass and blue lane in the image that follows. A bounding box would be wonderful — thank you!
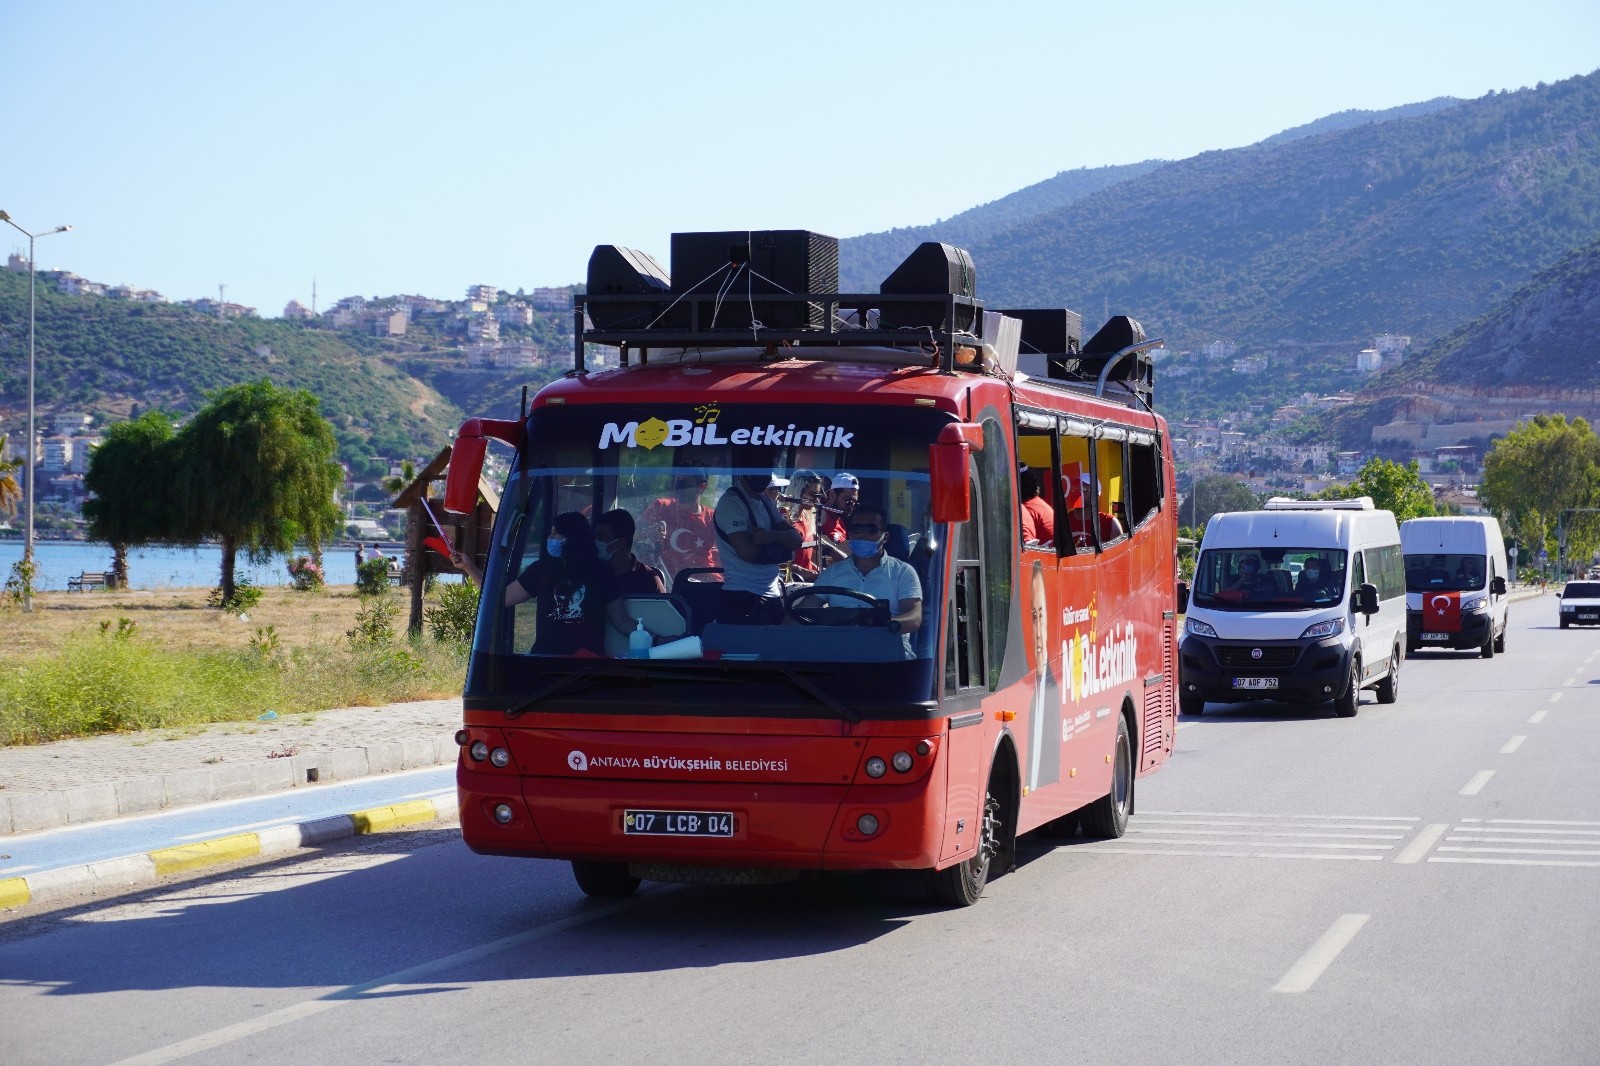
[0,698,461,837]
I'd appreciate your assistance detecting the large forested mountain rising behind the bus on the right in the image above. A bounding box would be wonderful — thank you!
[971,74,1600,352]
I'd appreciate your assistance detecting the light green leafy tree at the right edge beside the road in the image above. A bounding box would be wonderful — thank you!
[1478,415,1600,573]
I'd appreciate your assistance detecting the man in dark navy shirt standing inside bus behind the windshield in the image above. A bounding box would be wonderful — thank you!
[714,463,800,626]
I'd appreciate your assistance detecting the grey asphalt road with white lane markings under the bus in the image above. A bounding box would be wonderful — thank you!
[0,599,1600,1066]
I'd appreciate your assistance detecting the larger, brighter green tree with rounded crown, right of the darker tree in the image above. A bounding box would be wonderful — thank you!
[173,378,342,605]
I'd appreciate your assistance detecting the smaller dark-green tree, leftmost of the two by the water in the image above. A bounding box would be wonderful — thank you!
[83,411,178,587]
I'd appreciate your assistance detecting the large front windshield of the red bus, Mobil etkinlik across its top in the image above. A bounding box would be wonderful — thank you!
[467,402,949,717]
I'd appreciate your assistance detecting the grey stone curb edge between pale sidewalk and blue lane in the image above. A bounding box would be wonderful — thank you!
[0,735,461,837]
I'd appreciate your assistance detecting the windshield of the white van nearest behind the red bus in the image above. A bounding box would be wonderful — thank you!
[1190,547,1346,611]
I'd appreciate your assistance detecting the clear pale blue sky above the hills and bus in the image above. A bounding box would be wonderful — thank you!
[0,0,1600,317]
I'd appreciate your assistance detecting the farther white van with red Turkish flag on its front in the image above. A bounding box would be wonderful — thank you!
[1400,515,1510,659]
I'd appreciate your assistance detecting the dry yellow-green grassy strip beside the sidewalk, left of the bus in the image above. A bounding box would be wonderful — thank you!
[0,586,466,744]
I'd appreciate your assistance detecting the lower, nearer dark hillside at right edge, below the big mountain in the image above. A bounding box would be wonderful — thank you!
[1334,240,1600,447]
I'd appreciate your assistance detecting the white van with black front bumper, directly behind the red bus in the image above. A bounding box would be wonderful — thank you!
[1178,496,1405,717]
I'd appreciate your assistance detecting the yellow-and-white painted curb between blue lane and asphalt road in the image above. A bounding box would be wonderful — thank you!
[0,794,456,911]
